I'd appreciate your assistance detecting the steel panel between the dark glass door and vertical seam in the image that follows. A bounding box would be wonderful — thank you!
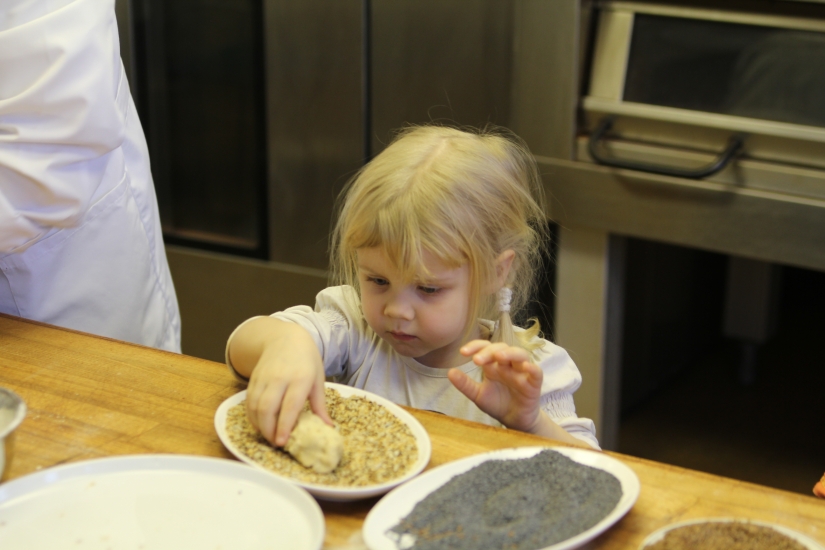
[264,0,364,269]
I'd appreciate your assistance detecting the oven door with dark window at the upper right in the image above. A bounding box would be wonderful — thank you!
[582,3,825,179]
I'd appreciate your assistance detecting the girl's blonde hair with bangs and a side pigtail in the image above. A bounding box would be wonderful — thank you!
[331,126,547,349]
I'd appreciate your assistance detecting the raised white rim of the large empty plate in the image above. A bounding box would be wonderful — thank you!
[0,453,326,550]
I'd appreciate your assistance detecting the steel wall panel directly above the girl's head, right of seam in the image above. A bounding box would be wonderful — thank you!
[371,0,514,153]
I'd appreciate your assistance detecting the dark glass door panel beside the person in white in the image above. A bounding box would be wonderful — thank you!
[132,0,266,256]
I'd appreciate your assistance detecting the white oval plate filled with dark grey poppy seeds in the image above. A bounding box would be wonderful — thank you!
[362,447,640,550]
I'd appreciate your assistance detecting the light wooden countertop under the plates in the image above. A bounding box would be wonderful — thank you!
[0,314,825,550]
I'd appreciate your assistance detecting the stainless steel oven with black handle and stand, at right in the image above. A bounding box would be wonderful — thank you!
[527,0,825,448]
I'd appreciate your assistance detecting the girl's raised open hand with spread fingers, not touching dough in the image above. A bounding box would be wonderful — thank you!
[447,340,543,432]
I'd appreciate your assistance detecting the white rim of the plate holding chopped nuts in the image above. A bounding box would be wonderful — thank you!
[215,382,432,502]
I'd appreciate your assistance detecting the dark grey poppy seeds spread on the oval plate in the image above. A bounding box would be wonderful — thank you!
[387,450,622,550]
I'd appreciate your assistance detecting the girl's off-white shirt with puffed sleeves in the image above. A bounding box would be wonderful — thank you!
[227,286,598,448]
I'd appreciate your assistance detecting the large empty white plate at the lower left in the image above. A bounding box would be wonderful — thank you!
[0,455,324,550]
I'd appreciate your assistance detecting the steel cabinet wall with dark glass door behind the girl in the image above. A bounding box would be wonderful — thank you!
[117,0,516,360]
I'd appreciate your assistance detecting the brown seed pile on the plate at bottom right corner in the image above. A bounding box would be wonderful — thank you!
[645,521,805,550]
